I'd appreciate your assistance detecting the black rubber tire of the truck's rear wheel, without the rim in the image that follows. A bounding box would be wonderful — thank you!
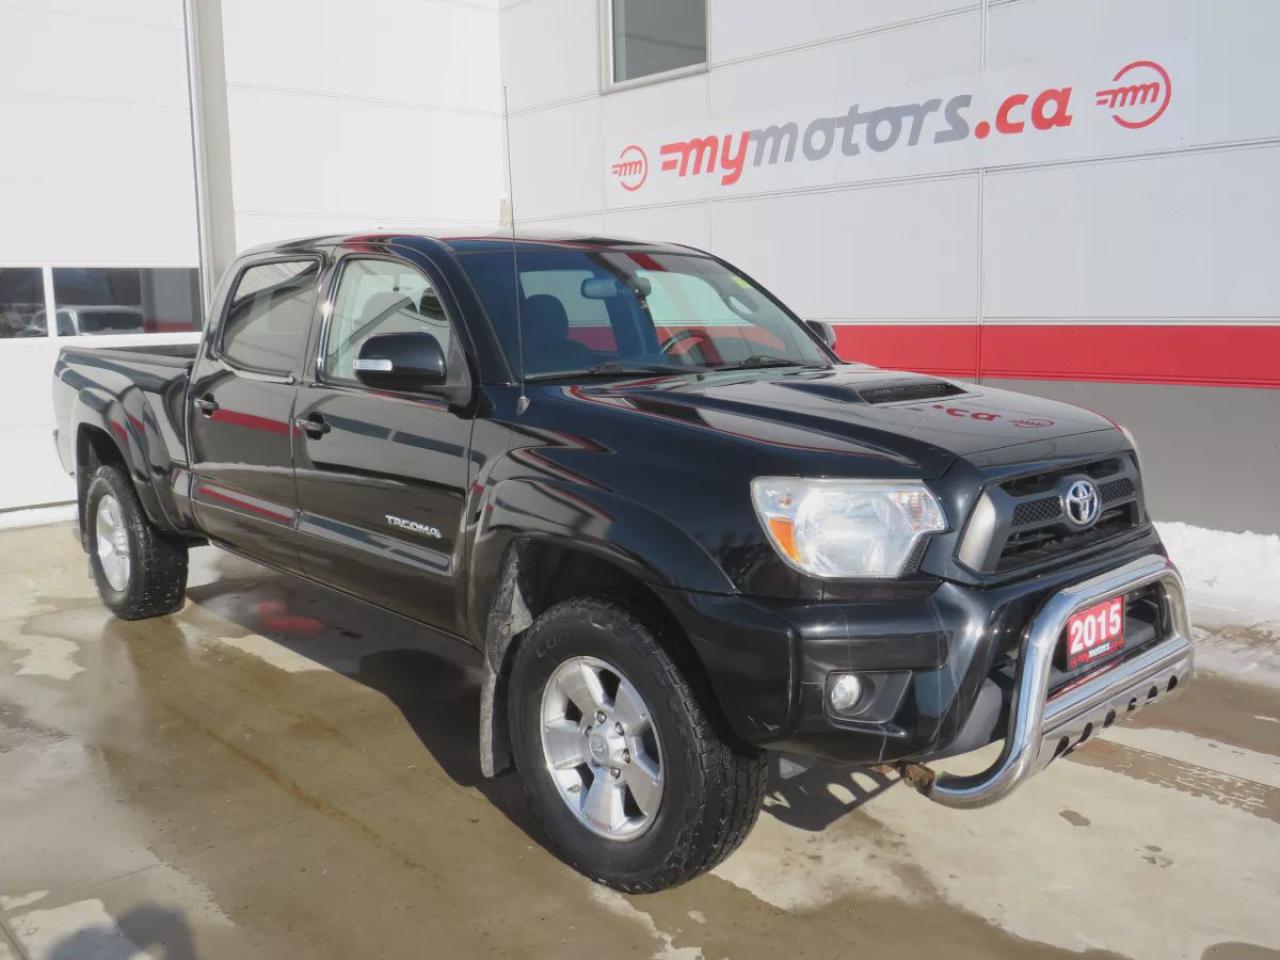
[82,465,187,620]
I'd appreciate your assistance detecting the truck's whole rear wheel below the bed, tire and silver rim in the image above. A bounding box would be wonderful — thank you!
[82,465,187,620]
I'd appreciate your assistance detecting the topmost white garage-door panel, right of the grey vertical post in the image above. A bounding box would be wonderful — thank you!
[223,0,502,113]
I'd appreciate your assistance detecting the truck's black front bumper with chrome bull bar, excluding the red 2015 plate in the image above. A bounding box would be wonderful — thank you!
[662,534,1192,806]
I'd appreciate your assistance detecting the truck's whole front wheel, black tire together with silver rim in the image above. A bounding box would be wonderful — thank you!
[507,599,767,893]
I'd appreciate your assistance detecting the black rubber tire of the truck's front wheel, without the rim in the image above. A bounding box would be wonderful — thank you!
[507,598,768,893]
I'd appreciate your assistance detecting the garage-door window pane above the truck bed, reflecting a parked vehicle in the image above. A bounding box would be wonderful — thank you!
[51,266,200,337]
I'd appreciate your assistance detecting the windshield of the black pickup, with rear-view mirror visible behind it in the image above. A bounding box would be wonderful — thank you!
[458,248,829,379]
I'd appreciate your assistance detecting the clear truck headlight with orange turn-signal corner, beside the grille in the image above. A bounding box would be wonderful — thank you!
[751,476,947,579]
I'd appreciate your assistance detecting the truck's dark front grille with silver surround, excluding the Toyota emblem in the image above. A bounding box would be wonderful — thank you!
[959,456,1146,575]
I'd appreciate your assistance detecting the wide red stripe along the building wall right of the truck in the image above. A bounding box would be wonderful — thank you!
[836,324,1280,388]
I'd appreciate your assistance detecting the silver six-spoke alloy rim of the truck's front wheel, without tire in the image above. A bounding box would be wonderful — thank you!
[541,657,663,840]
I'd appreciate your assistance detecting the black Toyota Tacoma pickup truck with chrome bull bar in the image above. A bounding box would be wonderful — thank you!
[54,234,1193,891]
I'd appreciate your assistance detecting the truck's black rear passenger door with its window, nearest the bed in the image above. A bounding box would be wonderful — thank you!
[189,259,321,570]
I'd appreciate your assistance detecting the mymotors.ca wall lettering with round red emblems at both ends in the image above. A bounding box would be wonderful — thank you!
[609,60,1172,193]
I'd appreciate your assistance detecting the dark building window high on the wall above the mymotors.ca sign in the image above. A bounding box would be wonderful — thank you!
[608,0,707,83]
